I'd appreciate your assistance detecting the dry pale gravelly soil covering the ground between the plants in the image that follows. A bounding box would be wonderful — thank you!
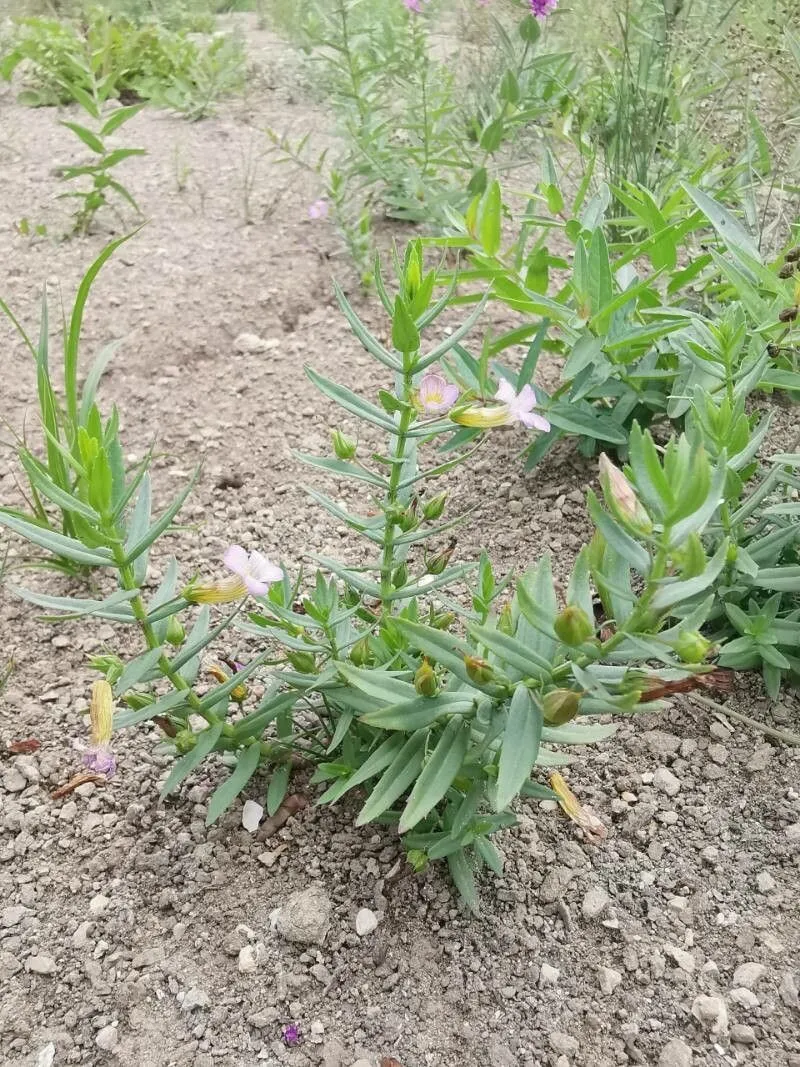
[0,14,800,1067]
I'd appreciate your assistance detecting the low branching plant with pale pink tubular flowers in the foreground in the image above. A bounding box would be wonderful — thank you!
[0,243,727,909]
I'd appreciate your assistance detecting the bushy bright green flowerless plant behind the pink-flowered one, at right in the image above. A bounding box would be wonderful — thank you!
[432,177,800,466]
